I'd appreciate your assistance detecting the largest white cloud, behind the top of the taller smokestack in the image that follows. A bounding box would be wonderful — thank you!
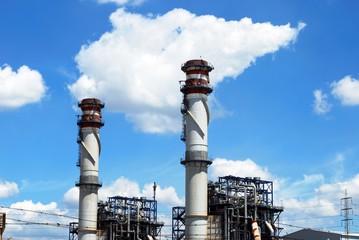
[68,9,305,133]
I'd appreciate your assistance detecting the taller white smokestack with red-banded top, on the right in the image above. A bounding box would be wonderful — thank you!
[181,60,213,239]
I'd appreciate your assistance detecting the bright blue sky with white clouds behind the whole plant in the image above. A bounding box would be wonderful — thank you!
[0,0,359,239]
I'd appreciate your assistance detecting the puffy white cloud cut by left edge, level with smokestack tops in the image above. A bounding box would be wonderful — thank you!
[0,65,46,109]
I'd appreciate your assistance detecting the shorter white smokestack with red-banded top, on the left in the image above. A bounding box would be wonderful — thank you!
[76,98,104,240]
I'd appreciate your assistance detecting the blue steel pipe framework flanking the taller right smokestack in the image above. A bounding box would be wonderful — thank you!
[172,176,283,240]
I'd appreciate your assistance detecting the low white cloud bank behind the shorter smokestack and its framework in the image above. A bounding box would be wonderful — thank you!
[63,177,184,207]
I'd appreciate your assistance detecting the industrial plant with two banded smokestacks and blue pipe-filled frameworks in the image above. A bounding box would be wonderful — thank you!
[69,59,283,240]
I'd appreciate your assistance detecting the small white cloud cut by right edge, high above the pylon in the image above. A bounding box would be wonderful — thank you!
[330,76,359,106]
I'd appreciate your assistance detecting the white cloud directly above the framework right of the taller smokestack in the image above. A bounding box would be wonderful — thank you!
[208,158,274,181]
